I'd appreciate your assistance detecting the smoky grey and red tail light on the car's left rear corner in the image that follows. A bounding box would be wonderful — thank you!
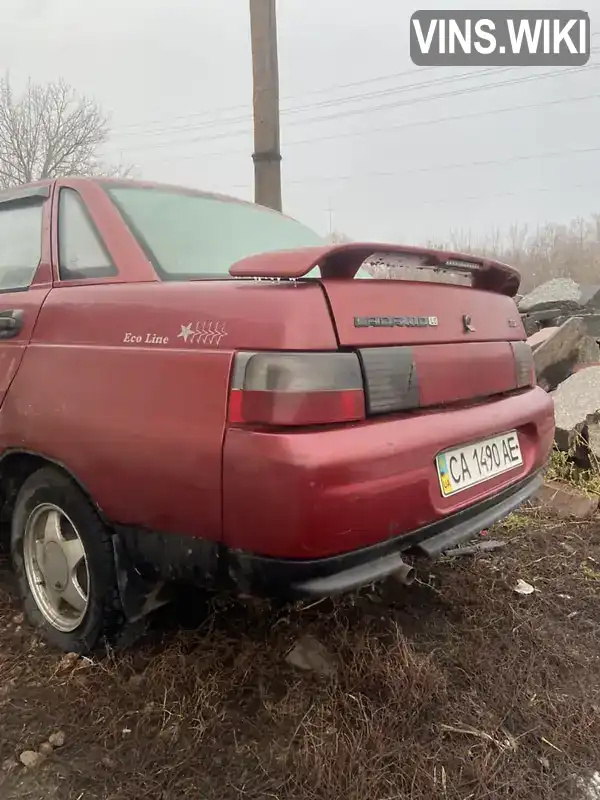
[228,352,365,425]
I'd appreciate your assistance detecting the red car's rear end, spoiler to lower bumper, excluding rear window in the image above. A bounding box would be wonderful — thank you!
[223,245,554,596]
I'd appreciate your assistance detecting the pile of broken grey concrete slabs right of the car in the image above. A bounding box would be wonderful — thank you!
[518,278,600,469]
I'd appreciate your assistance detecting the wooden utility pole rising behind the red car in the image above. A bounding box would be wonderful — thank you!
[250,0,281,211]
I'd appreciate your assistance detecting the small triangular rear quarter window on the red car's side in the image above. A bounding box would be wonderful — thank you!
[58,189,117,281]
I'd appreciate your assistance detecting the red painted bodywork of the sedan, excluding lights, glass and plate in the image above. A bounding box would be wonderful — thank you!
[0,180,553,557]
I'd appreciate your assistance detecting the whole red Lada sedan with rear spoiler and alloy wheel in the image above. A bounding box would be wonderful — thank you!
[0,179,554,652]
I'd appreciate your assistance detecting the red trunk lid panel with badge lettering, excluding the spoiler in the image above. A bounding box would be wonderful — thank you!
[323,279,528,414]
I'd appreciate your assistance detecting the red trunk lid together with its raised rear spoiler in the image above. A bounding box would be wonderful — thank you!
[231,244,534,415]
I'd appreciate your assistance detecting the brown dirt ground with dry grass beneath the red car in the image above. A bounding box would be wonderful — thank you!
[0,515,600,800]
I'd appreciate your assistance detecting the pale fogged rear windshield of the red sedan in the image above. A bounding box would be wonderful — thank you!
[105,184,324,280]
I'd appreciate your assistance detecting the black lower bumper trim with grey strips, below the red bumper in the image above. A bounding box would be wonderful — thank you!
[228,472,542,599]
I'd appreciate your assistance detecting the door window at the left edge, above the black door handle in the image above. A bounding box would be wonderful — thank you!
[0,199,43,291]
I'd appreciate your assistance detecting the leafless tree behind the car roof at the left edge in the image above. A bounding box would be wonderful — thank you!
[0,75,131,188]
